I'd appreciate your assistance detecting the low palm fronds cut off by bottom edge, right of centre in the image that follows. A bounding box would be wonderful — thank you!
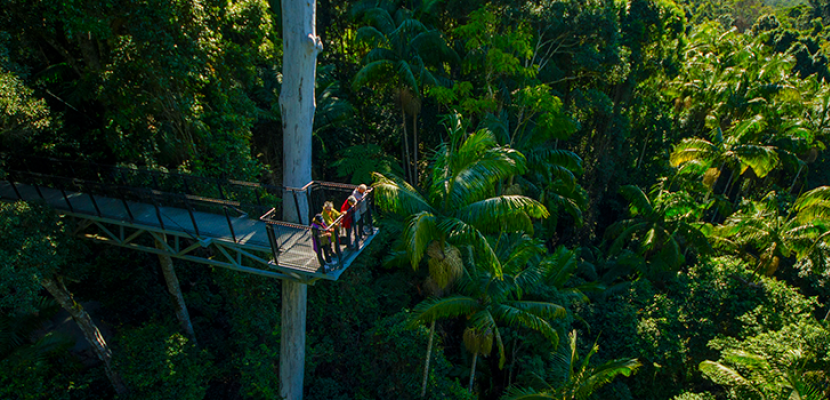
[503,331,641,400]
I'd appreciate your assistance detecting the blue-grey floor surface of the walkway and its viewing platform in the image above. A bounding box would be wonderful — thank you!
[0,181,377,280]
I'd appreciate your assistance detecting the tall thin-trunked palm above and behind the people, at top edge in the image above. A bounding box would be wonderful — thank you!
[352,2,458,186]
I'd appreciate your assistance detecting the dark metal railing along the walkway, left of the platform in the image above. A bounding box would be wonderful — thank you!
[1,157,283,243]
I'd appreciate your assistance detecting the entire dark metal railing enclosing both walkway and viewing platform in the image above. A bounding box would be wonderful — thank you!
[0,154,373,274]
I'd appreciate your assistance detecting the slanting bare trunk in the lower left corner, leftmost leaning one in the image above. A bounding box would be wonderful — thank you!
[40,276,129,396]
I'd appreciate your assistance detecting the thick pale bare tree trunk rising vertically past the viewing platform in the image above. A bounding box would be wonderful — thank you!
[280,0,323,400]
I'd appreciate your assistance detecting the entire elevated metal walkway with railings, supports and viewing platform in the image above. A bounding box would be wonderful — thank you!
[0,159,378,284]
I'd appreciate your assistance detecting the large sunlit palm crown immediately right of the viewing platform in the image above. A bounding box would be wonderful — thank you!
[373,111,549,276]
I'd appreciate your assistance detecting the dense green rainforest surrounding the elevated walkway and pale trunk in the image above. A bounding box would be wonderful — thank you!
[0,0,830,400]
